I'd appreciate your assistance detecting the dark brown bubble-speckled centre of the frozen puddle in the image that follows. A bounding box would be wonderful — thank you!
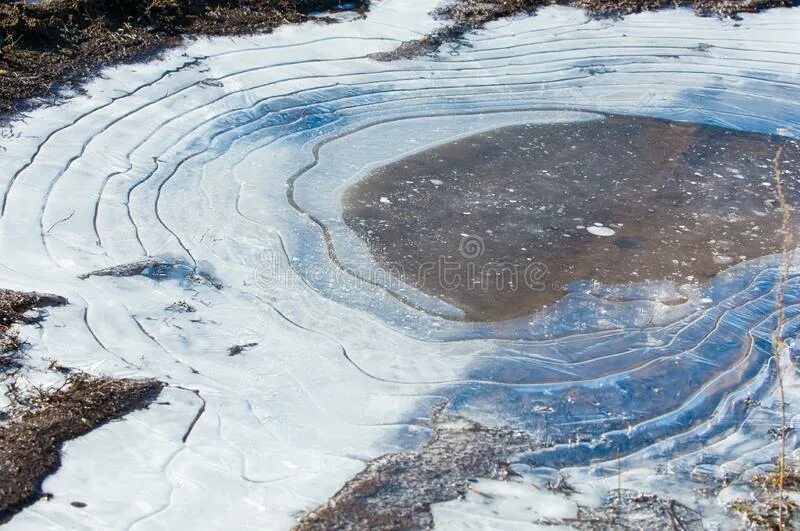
[344,116,800,321]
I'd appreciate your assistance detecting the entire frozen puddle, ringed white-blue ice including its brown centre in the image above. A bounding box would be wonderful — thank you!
[0,0,800,529]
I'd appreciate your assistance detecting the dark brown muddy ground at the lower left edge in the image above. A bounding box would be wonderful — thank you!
[0,289,163,524]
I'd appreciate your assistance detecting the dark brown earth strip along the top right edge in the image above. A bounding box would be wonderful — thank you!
[373,0,798,61]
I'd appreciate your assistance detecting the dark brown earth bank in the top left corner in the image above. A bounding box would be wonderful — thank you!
[0,0,361,122]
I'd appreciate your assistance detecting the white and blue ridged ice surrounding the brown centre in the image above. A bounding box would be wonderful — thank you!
[0,0,800,529]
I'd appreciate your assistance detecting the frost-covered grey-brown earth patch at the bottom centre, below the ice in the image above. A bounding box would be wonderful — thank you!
[295,408,534,531]
